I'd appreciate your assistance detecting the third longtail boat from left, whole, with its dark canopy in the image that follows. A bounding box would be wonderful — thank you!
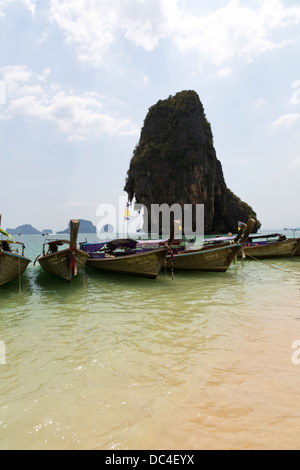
[80,238,170,279]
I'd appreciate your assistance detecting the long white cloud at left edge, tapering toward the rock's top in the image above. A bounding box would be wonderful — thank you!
[0,66,138,141]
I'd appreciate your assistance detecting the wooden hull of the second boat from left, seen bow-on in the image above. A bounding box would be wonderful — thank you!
[37,249,89,281]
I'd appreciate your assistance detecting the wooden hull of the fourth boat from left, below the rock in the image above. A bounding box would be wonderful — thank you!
[167,245,241,272]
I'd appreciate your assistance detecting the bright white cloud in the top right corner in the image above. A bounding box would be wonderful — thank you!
[174,0,300,66]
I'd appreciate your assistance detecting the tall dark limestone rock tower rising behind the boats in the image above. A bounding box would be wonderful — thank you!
[124,91,260,234]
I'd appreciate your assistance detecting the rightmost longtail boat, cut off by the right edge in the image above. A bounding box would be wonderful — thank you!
[238,233,299,259]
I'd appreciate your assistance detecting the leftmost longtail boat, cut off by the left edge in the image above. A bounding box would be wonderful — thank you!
[0,214,31,286]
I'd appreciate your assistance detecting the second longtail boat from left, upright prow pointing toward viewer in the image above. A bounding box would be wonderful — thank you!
[34,220,89,281]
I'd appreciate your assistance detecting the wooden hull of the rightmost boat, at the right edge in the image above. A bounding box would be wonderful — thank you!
[238,239,298,259]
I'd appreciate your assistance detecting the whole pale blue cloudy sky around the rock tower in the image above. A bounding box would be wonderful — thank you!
[0,0,300,231]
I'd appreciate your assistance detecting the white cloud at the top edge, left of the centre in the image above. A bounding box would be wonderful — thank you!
[50,0,173,65]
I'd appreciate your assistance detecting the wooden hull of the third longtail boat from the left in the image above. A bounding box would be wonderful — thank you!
[86,248,169,279]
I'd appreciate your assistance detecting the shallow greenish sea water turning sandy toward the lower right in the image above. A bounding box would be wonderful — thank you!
[0,236,300,449]
